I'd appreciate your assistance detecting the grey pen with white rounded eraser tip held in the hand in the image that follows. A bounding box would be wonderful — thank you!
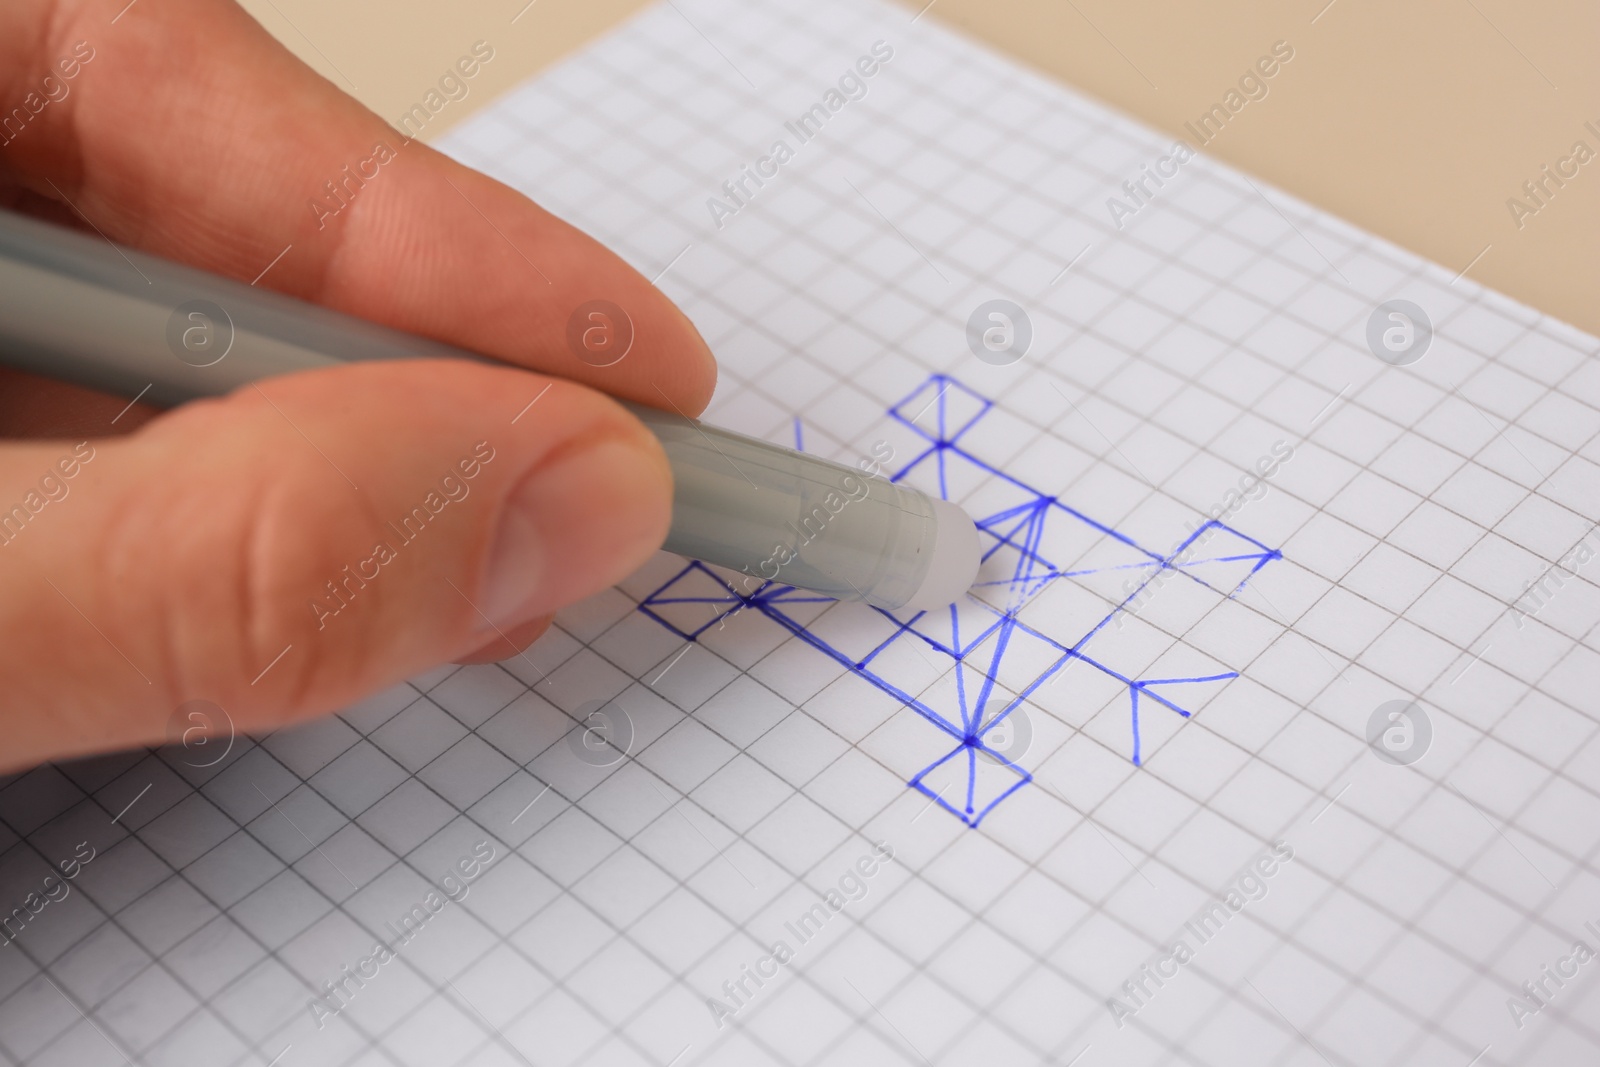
[0,211,981,611]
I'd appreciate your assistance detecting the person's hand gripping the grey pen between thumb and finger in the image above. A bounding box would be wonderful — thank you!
[0,0,715,769]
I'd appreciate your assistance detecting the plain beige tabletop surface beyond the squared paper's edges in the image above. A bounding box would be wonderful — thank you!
[245,0,1600,334]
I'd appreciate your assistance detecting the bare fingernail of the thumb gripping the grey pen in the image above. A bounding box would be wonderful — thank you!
[478,438,672,633]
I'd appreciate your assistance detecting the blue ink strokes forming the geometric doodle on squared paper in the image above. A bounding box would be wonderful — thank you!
[638,374,1283,827]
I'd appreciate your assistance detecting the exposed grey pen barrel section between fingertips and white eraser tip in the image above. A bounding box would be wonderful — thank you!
[629,405,936,609]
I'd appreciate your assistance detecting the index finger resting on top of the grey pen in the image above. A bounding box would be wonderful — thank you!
[0,0,715,414]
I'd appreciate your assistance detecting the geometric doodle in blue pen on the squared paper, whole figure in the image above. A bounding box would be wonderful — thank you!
[638,374,1282,827]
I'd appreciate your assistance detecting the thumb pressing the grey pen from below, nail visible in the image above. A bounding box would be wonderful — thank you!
[0,362,672,771]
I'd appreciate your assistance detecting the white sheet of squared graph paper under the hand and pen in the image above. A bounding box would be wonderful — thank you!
[0,0,1600,1067]
